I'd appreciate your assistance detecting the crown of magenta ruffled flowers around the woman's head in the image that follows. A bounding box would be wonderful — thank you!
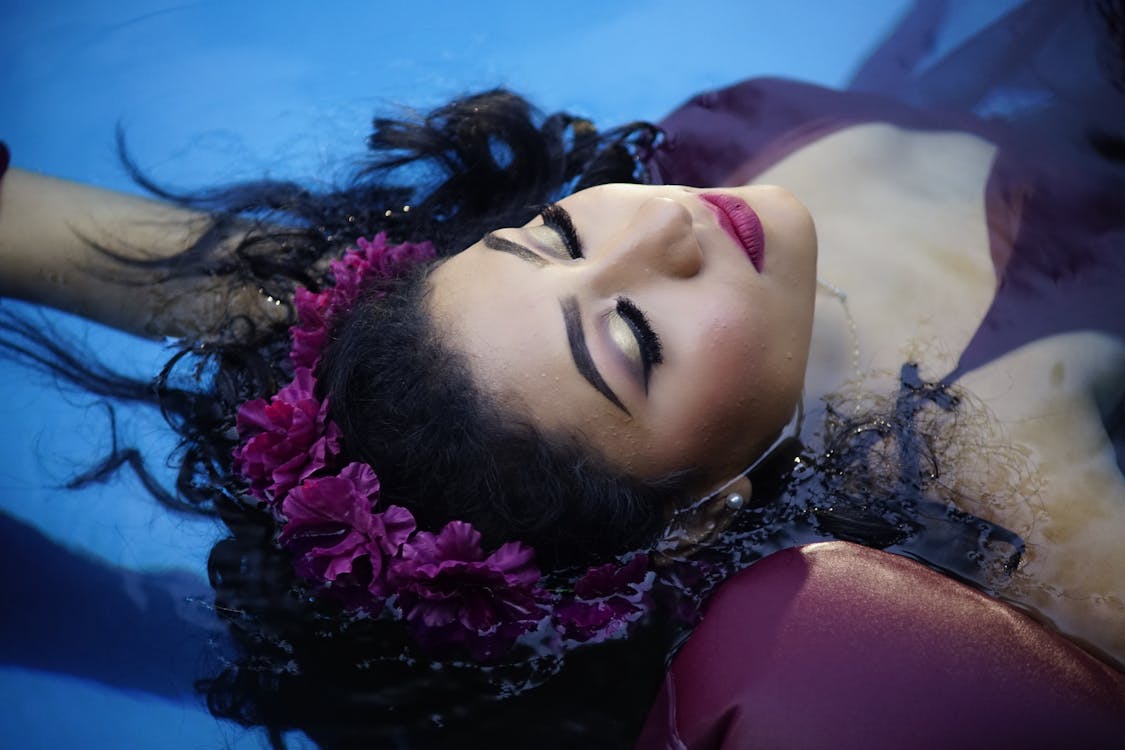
[234,234,654,660]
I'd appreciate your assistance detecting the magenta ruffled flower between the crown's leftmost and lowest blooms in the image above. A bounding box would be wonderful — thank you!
[278,463,414,597]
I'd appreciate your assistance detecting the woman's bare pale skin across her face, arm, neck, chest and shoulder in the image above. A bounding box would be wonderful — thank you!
[0,125,1125,665]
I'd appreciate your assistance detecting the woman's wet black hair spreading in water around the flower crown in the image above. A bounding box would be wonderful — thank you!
[5,90,690,748]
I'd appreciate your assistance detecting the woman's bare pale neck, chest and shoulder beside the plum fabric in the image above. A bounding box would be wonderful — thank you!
[762,125,1125,665]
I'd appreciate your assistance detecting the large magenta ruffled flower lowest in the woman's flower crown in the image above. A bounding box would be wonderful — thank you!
[389,521,545,659]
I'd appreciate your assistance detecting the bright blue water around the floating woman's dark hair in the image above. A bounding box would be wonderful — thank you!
[0,0,1011,750]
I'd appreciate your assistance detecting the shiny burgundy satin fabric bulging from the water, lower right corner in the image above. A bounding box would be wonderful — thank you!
[637,542,1125,750]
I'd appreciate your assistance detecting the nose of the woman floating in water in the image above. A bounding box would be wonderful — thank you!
[597,197,703,290]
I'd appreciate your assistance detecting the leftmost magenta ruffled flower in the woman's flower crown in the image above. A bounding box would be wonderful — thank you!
[234,368,340,505]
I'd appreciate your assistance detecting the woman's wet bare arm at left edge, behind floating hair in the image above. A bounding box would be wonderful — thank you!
[0,169,284,337]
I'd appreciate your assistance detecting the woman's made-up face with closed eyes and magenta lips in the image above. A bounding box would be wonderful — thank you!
[429,184,817,493]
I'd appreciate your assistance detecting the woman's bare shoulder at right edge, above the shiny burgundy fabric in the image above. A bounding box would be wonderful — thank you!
[963,332,1125,665]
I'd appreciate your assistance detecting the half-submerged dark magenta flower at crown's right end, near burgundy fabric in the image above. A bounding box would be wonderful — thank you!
[555,554,653,643]
